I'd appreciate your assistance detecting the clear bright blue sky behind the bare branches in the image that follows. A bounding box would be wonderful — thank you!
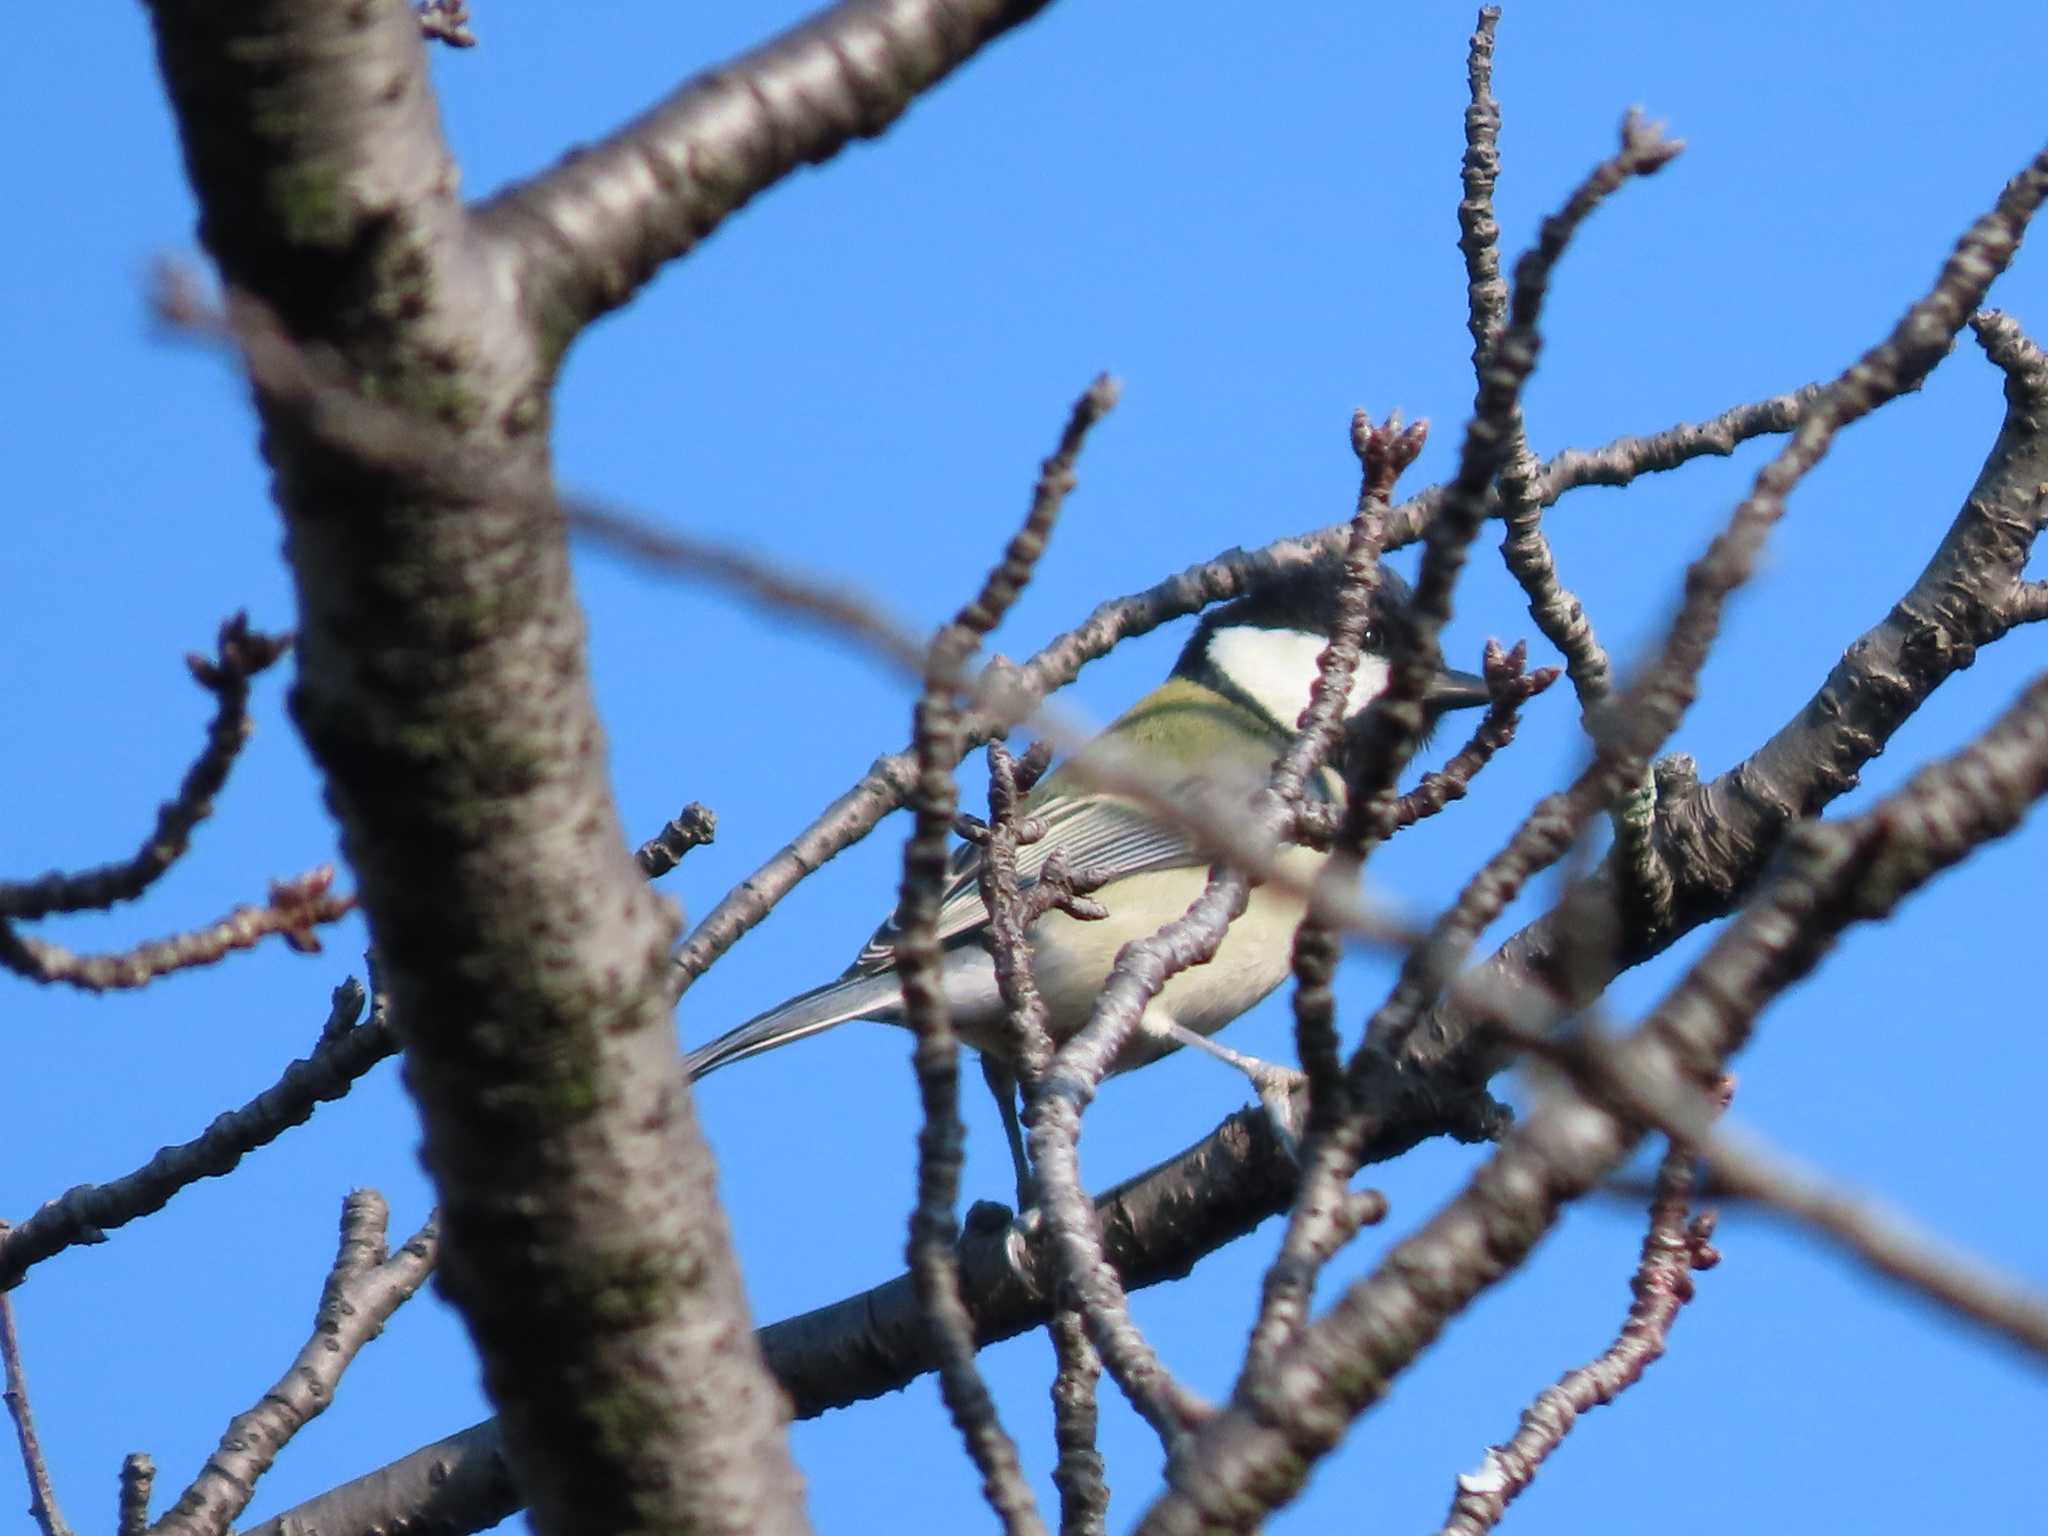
[0,0,2048,1534]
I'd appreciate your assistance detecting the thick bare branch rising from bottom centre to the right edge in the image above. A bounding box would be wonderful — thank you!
[1139,678,2048,1536]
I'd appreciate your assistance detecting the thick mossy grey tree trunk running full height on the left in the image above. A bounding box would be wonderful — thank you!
[138,0,803,1536]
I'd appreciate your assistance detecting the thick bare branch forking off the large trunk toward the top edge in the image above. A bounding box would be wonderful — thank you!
[479,0,1044,340]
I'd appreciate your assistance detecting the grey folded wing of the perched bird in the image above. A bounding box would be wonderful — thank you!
[848,795,1210,975]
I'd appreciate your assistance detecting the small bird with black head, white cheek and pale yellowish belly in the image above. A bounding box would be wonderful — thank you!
[686,555,1489,1116]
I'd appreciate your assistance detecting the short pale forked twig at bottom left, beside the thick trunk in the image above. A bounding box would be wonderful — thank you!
[152,1190,438,1536]
